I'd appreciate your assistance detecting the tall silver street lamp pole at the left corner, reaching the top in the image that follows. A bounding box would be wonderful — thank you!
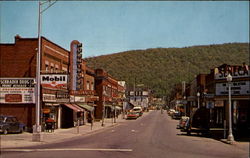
[32,0,56,142]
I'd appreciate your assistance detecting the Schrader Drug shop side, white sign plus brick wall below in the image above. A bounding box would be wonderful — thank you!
[0,78,35,131]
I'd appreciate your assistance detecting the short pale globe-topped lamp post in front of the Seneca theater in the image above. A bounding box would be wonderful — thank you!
[226,74,234,143]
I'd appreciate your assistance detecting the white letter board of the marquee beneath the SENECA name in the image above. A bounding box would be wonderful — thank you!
[216,81,250,96]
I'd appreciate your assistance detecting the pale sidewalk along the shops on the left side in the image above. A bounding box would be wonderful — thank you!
[0,115,127,149]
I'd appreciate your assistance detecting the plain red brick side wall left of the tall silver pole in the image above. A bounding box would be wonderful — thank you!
[0,35,38,131]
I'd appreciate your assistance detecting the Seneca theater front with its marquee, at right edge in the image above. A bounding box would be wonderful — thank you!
[215,65,250,137]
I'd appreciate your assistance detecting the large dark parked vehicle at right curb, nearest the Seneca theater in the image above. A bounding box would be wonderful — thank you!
[181,107,210,135]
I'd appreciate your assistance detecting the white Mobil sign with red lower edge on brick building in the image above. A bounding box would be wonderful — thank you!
[41,74,68,89]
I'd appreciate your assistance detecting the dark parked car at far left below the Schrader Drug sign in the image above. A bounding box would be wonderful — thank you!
[0,115,25,134]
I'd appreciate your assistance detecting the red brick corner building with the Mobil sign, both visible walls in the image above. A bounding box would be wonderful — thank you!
[0,35,79,130]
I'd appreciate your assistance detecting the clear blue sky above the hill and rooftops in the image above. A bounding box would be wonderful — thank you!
[0,1,249,57]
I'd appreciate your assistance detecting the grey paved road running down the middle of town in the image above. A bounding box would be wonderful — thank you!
[1,111,249,158]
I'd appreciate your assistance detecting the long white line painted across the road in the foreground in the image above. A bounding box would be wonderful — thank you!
[1,148,133,152]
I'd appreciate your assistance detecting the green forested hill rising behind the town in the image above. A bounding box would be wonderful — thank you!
[86,43,249,96]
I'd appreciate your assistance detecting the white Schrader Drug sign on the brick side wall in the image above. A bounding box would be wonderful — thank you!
[0,78,35,104]
